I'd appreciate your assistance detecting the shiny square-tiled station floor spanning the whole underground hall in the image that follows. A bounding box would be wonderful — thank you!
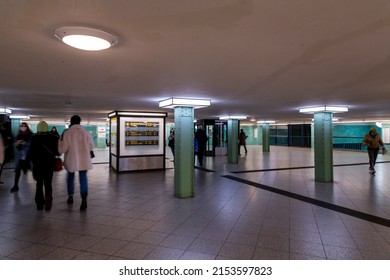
[0,146,390,260]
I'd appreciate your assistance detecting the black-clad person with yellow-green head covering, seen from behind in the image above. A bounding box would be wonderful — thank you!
[29,121,59,211]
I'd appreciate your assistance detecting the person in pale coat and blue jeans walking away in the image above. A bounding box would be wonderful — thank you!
[58,115,93,210]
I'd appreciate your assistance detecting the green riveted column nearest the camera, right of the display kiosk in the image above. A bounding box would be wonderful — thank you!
[175,107,194,198]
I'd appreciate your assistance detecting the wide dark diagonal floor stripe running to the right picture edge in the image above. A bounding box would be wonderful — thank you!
[222,175,390,227]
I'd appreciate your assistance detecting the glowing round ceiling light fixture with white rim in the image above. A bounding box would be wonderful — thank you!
[54,26,118,51]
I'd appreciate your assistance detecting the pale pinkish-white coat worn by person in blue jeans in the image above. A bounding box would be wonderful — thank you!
[58,124,93,172]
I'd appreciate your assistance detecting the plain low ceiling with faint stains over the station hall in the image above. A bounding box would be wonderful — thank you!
[0,0,390,122]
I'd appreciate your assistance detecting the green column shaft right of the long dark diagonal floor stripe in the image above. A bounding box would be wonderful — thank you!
[314,112,333,182]
